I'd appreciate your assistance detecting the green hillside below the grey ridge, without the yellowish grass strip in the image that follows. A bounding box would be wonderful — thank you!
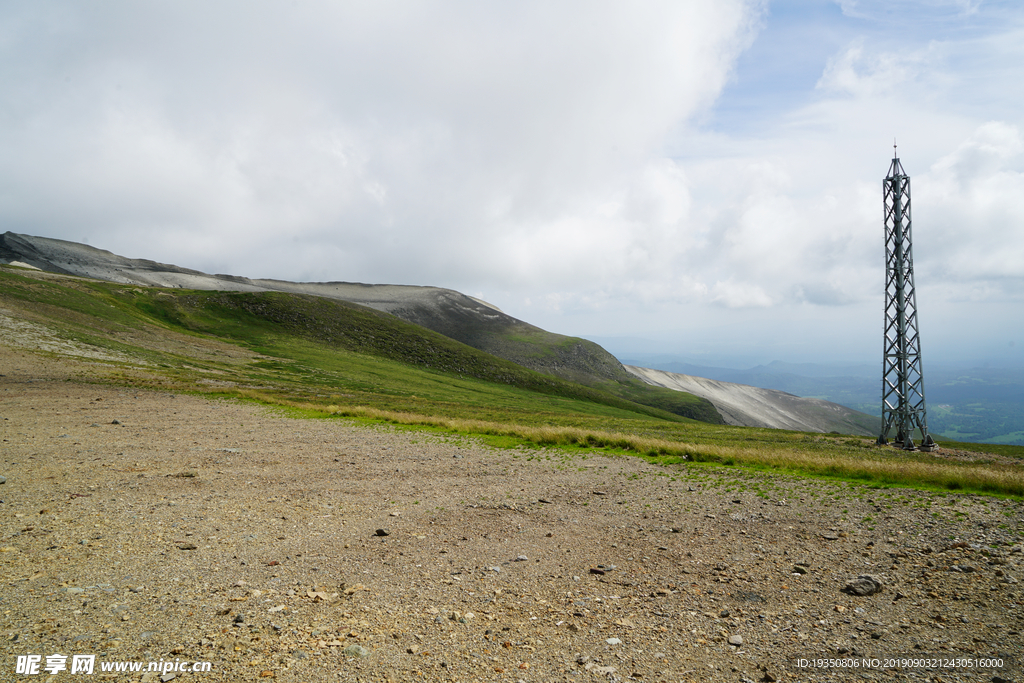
[0,269,689,424]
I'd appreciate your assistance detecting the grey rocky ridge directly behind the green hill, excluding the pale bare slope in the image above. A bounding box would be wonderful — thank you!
[0,232,722,424]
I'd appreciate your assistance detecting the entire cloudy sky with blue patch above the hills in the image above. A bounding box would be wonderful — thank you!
[0,0,1024,365]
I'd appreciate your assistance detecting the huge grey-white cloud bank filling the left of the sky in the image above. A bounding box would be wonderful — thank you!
[0,0,758,285]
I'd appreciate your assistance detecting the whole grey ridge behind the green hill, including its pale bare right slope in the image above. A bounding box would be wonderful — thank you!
[0,228,877,435]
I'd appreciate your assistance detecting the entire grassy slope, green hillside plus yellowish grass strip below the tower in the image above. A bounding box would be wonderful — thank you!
[6,267,1024,496]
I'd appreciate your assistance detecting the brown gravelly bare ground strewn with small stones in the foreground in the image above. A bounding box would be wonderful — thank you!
[0,346,1024,683]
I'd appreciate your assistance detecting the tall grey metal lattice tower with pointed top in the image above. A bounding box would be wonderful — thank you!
[878,144,935,451]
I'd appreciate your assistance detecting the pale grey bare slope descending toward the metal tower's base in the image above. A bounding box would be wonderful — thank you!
[625,366,878,435]
